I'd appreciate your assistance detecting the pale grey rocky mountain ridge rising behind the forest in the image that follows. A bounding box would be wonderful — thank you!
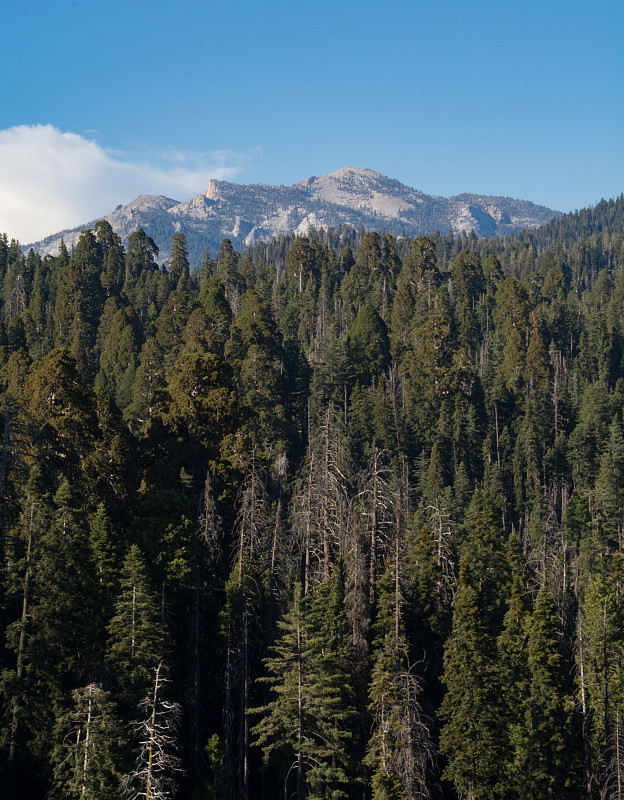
[29,167,560,263]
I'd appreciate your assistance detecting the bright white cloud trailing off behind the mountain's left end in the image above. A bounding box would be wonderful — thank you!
[0,125,253,244]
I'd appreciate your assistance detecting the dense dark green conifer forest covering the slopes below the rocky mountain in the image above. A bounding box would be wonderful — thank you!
[0,197,624,800]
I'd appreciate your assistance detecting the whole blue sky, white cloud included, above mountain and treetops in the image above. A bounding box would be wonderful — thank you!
[0,0,624,242]
